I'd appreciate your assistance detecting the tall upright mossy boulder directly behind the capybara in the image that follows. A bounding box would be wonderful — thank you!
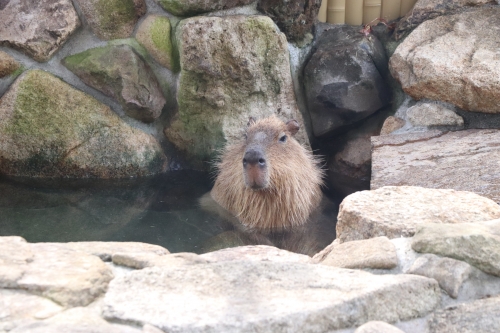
[165,16,308,161]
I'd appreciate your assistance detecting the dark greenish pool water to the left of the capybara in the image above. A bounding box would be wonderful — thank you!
[0,171,222,252]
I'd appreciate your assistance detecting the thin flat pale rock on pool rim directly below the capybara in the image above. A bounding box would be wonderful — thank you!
[200,245,311,264]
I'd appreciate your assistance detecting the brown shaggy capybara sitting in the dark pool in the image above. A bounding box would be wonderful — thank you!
[211,116,323,230]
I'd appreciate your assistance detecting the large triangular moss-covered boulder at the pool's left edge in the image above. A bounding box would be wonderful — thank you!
[0,70,166,178]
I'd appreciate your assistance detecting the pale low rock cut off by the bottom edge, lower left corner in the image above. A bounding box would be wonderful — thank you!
[10,308,142,333]
